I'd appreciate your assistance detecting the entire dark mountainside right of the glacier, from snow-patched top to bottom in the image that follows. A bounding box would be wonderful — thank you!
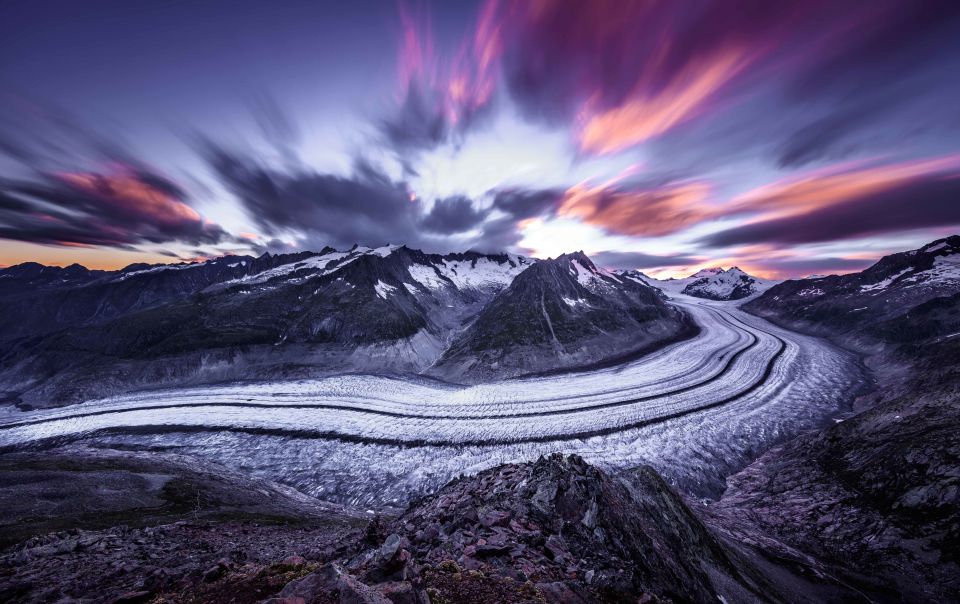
[717,237,960,602]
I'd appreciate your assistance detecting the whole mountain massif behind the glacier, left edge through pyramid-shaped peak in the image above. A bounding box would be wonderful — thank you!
[0,246,694,408]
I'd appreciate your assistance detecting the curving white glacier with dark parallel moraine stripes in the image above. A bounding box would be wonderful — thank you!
[0,296,864,506]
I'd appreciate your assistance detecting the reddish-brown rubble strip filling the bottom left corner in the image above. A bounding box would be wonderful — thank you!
[0,521,361,603]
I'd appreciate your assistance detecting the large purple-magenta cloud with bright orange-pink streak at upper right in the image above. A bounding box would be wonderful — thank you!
[484,0,960,156]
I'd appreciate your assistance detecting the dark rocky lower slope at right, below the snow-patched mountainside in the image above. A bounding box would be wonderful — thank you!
[712,332,960,602]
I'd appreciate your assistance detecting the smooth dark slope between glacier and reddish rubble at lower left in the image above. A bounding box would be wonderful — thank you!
[0,446,367,548]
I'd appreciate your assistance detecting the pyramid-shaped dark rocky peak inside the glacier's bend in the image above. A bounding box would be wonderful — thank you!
[431,252,695,379]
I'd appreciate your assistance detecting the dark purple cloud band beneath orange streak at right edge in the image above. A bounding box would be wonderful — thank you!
[700,174,960,247]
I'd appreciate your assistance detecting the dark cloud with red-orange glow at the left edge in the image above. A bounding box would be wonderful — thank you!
[0,104,232,248]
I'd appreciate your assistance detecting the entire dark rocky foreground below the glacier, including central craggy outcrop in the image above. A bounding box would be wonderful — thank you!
[0,450,872,604]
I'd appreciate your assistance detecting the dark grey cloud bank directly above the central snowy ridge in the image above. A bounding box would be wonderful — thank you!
[200,140,547,251]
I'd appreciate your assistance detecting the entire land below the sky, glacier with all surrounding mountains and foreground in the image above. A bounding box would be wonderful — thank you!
[0,238,960,604]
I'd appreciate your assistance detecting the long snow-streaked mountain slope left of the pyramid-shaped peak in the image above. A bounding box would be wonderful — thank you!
[0,247,531,406]
